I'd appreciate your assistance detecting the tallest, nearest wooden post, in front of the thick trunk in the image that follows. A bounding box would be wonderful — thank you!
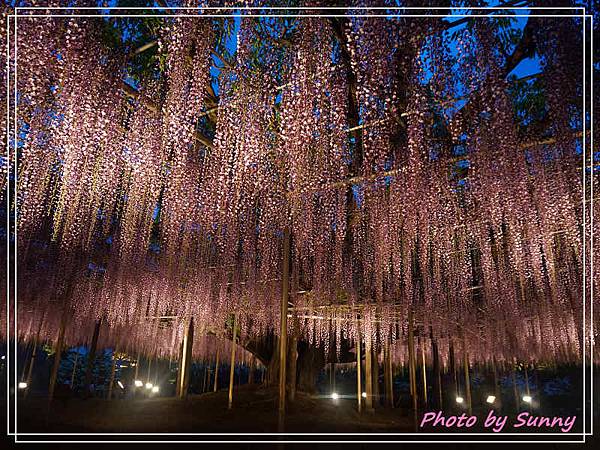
[278,226,290,432]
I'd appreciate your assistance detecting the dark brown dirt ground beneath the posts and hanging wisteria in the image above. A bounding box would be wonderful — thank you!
[17,386,413,433]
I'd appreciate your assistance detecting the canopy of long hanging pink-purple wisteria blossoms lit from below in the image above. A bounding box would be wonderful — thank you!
[0,0,600,372]
